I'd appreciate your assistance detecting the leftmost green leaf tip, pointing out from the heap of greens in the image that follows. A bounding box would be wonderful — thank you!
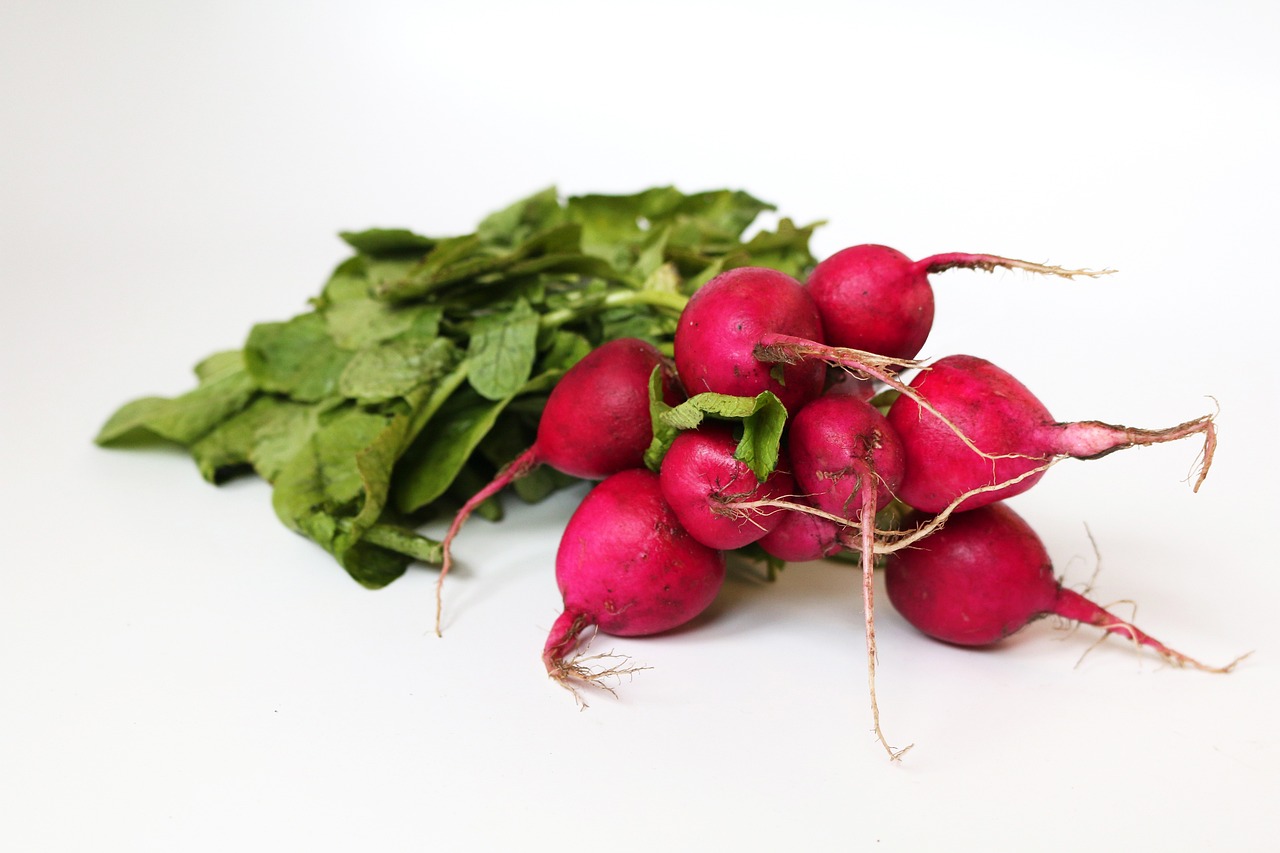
[93,351,256,446]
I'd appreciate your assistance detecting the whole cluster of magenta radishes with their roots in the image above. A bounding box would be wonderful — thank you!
[438,246,1234,758]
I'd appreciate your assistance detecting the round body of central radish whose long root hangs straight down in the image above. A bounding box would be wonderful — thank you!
[787,394,905,520]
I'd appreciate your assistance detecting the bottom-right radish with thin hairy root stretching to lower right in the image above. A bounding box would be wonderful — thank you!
[884,503,1239,672]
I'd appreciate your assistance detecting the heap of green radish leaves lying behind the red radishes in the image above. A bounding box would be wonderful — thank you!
[96,187,819,588]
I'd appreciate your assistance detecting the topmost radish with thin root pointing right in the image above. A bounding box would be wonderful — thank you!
[805,243,1110,359]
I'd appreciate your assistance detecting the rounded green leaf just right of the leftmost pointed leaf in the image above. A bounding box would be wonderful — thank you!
[244,311,352,402]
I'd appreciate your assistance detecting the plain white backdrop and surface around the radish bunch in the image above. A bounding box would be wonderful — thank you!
[0,0,1280,850]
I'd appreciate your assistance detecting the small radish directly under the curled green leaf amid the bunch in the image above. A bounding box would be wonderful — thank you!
[659,423,795,551]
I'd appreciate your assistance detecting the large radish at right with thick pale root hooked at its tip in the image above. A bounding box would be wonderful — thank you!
[888,355,1216,512]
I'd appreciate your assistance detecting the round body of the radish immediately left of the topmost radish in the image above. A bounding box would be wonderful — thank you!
[675,266,826,412]
